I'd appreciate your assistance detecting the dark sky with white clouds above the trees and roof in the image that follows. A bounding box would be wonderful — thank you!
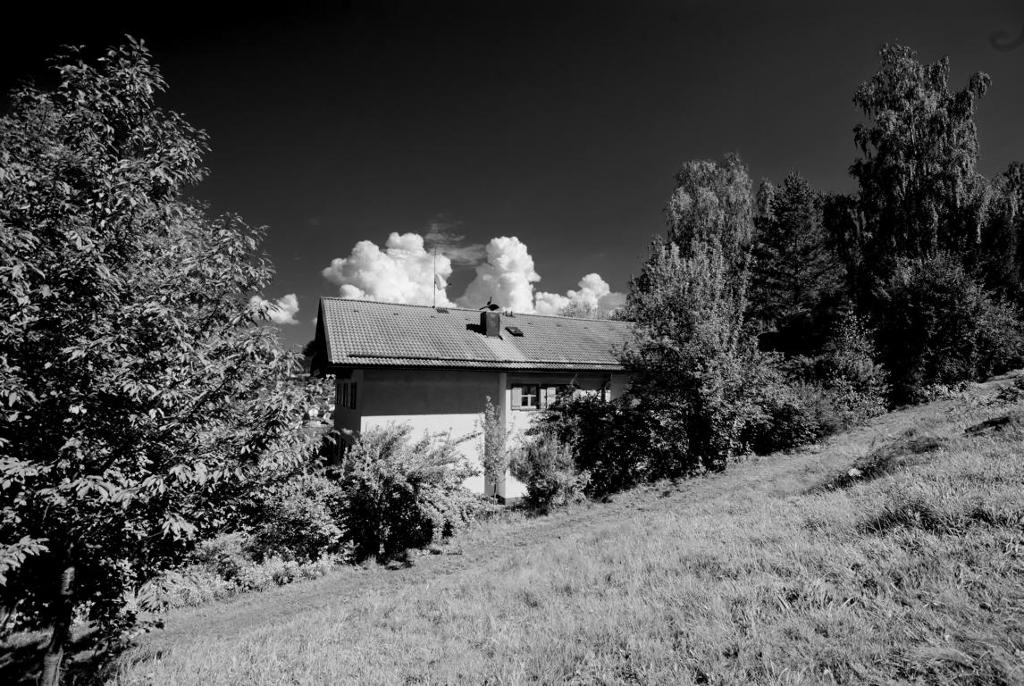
[0,0,1024,345]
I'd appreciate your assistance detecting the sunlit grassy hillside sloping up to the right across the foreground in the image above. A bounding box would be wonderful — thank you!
[108,379,1024,685]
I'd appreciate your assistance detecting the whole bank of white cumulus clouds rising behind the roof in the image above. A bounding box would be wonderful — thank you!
[323,229,626,316]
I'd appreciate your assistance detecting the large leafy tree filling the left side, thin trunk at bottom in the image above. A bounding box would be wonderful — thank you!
[0,41,317,685]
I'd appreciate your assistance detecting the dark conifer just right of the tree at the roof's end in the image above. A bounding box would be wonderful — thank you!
[750,174,844,354]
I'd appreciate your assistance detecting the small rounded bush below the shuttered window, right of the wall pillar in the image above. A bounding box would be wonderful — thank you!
[511,431,590,512]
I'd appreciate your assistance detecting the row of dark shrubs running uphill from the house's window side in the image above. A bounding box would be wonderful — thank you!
[512,316,888,510]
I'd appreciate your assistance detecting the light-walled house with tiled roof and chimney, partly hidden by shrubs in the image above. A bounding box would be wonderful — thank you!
[312,298,631,500]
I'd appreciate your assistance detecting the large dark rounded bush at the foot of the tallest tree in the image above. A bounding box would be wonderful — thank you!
[878,253,1024,402]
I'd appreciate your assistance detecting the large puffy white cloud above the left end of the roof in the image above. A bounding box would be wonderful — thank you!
[323,231,452,305]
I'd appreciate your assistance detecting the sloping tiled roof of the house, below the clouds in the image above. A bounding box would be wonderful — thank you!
[317,298,630,371]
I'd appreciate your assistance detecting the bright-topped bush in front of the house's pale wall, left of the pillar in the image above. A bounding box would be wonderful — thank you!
[340,425,480,560]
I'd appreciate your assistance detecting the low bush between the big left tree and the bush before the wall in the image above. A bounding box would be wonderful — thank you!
[251,475,345,561]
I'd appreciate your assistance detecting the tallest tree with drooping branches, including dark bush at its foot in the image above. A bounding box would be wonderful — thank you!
[828,45,1020,402]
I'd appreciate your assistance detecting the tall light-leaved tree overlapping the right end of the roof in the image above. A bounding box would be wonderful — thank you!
[623,156,755,469]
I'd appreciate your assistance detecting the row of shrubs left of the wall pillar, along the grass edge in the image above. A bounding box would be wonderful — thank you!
[134,425,487,608]
